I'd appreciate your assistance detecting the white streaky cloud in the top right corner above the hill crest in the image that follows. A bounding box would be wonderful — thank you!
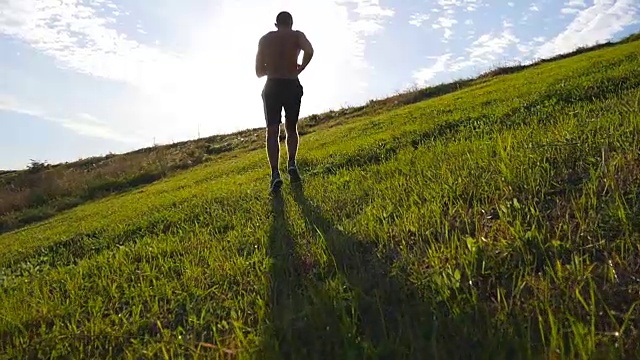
[536,0,639,58]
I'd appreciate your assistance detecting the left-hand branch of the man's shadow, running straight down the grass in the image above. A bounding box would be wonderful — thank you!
[260,190,410,359]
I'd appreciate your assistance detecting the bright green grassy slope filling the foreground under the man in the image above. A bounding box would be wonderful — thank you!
[0,33,640,359]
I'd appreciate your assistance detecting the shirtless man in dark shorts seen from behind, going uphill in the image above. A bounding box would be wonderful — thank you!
[256,11,313,191]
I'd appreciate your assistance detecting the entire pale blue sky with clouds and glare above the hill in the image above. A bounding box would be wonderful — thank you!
[0,0,640,169]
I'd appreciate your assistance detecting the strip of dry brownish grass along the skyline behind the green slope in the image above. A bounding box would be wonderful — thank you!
[0,34,640,234]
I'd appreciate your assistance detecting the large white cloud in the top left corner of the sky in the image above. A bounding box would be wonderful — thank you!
[0,0,180,87]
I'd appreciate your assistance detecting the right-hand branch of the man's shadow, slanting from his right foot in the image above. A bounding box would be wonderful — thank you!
[291,185,435,359]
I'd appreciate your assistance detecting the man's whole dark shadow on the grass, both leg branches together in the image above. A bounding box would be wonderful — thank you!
[261,187,544,360]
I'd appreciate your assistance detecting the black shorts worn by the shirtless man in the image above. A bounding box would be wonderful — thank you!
[262,79,303,126]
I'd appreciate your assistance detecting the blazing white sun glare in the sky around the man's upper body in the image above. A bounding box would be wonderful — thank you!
[126,0,366,146]
